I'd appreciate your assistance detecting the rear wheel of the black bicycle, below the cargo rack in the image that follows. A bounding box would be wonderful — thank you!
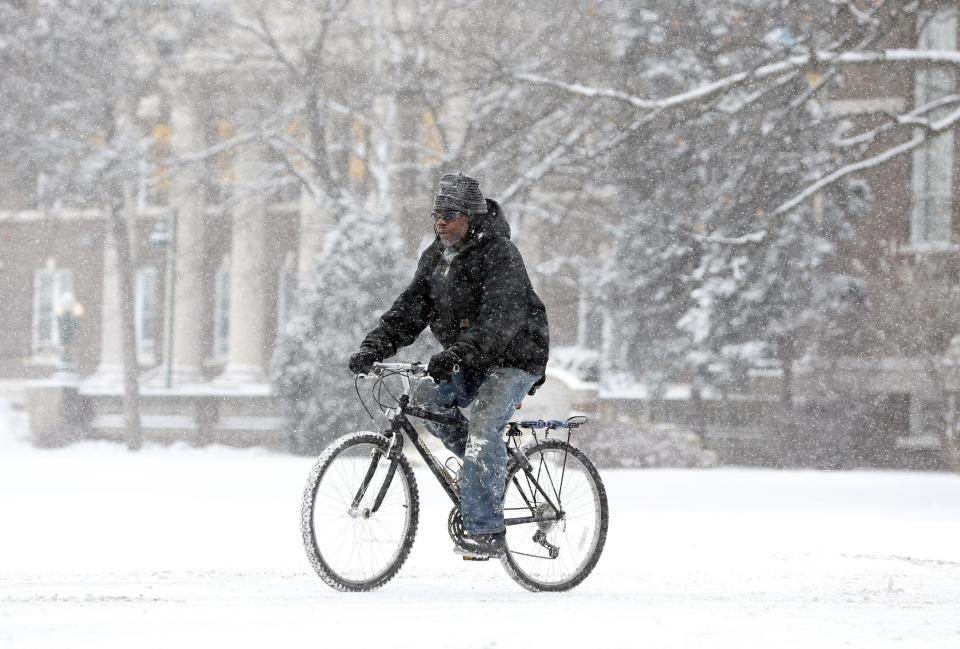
[501,439,609,591]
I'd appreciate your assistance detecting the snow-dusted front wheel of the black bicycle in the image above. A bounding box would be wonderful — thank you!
[300,432,420,591]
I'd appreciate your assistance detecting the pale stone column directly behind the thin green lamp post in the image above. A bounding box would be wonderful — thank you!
[155,78,204,386]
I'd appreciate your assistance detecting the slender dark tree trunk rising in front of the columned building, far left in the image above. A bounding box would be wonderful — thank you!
[110,196,143,450]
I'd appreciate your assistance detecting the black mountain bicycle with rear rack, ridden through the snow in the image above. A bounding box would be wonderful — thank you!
[300,363,609,591]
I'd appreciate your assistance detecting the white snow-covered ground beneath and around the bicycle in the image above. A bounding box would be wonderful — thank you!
[0,420,960,649]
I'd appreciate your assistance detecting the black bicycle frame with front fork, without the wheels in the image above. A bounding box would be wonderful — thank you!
[353,374,563,525]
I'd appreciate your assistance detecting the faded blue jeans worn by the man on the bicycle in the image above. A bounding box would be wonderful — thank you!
[411,367,540,534]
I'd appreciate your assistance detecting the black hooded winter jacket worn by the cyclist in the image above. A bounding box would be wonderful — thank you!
[361,199,550,376]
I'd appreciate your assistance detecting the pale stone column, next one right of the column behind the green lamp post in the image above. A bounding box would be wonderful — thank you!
[216,133,267,387]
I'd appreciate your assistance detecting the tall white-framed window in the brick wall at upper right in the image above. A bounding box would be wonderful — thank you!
[910,8,958,246]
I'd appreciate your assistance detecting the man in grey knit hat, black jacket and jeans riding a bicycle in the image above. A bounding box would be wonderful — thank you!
[350,173,549,557]
